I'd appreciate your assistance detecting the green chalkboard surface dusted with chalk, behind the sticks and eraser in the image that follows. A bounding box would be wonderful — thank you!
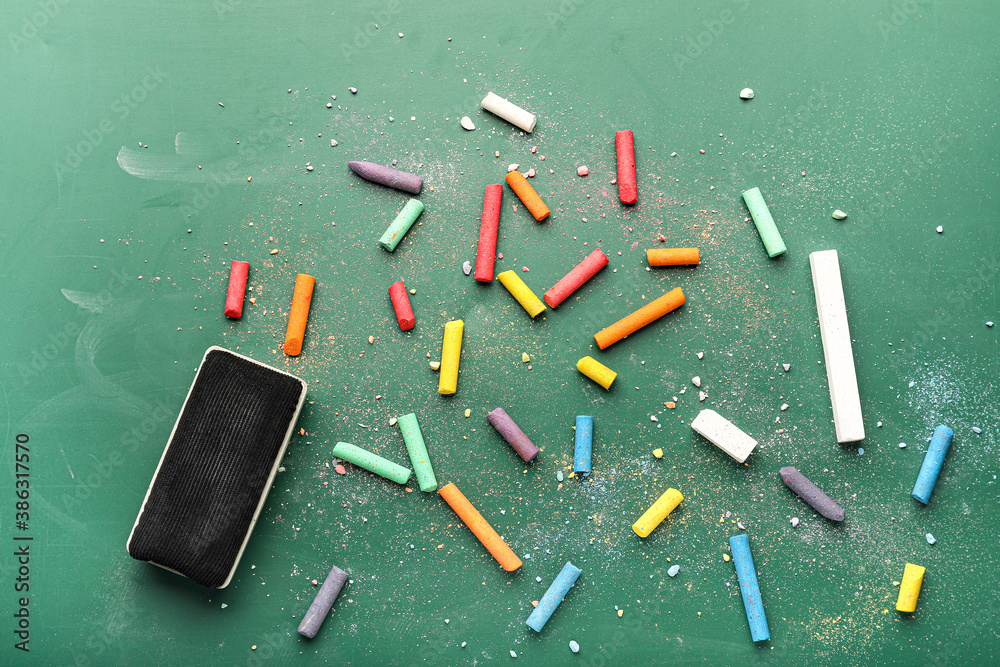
[0,0,1000,665]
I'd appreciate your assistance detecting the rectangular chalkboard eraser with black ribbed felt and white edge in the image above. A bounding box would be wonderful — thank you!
[128,347,306,588]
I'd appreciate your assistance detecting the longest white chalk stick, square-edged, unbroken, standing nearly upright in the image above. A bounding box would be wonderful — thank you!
[809,250,865,442]
